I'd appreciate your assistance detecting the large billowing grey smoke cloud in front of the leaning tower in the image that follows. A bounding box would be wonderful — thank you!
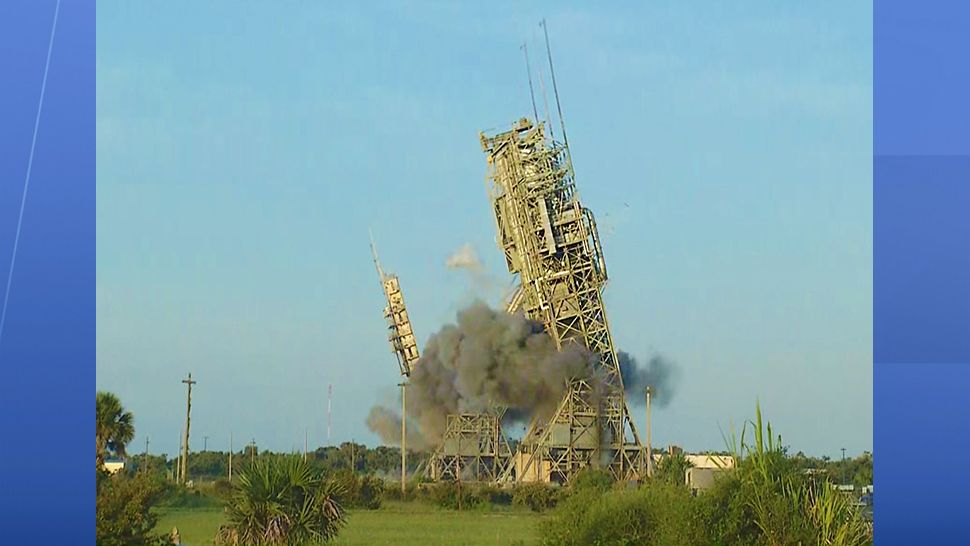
[368,301,596,447]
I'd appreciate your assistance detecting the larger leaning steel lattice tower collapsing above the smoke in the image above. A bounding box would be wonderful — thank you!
[481,118,646,483]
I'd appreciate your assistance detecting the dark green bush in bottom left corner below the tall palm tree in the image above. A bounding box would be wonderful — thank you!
[95,471,166,546]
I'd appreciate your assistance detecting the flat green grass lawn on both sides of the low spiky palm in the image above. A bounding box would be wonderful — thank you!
[157,503,542,546]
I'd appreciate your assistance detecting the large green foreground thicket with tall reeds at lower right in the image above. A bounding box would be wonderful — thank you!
[536,402,872,546]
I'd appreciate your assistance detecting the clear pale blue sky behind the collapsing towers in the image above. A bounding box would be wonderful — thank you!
[97,1,872,457]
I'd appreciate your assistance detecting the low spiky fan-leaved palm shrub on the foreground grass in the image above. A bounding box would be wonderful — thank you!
[216,457,346,545]
